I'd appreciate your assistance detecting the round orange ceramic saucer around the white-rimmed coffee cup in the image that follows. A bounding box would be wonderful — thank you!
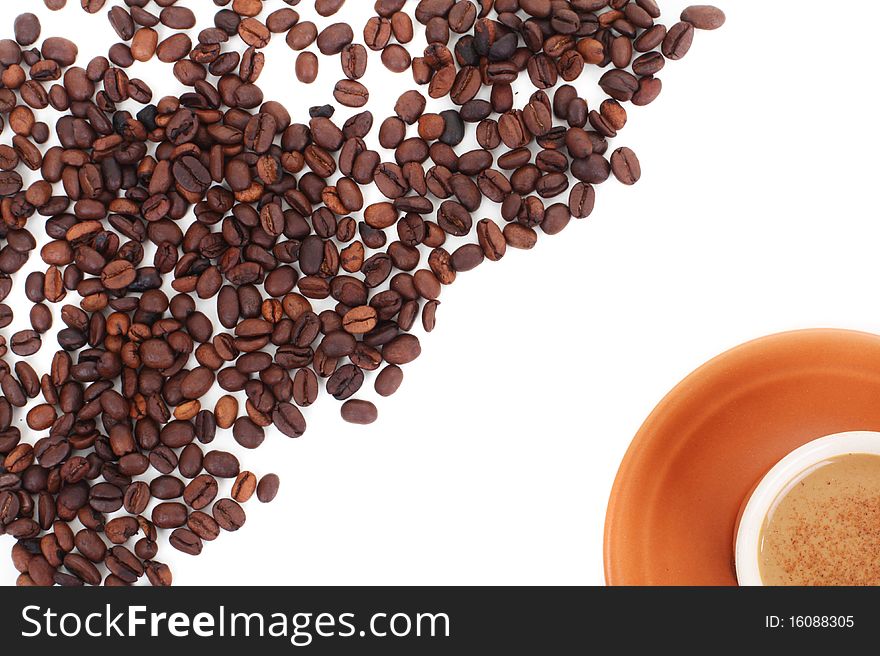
[605,330,880,585]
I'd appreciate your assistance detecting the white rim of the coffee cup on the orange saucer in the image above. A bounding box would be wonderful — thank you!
[735,431,880,586]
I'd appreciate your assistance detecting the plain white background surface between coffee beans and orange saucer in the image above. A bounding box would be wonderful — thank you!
[6,0,880,585]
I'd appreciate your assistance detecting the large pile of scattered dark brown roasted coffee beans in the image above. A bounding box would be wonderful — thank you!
[0,0,724,585]
